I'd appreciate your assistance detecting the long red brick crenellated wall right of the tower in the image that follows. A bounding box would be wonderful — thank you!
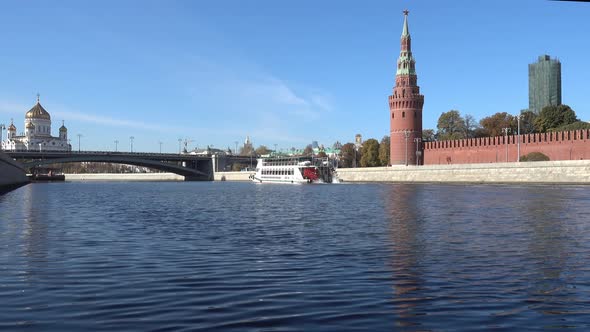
[424,129,590,165]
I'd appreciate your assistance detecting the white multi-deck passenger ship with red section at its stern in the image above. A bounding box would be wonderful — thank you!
[250,158,337,184]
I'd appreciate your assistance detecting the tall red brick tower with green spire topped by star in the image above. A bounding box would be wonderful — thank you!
[389,10,424,165]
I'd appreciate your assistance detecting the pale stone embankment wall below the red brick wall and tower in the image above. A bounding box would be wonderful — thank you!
[338,160,590,184]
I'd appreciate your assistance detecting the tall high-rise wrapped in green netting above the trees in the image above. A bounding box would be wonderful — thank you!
[529,55,561,113]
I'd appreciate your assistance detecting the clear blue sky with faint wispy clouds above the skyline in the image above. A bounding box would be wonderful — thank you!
[0,0,590,152]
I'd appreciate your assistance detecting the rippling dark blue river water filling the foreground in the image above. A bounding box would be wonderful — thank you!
[0,182,590,331]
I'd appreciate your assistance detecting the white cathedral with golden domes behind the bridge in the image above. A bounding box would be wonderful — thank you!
[2,95,72,151]
